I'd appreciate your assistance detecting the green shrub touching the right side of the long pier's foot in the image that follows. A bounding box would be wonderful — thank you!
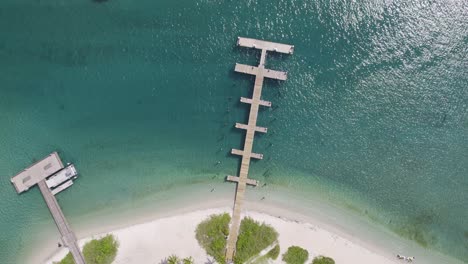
[234,217,278,264]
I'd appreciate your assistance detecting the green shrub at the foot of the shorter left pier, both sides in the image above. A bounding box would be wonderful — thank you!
[59,235,119,264]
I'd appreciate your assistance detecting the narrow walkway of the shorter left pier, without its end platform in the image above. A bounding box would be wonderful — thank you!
[37,180,85,264]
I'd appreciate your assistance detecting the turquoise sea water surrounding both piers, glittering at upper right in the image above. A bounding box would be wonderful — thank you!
[0,0,468,263]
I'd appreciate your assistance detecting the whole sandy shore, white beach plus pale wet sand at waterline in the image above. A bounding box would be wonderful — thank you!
[33,185,462,264]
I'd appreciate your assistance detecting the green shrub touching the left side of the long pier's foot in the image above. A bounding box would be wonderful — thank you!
[195,213,231,264]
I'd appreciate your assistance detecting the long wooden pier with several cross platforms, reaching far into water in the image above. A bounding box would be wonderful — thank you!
[226,37,294,263]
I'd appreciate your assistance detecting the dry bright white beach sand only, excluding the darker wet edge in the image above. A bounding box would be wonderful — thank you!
[46,207,405,264]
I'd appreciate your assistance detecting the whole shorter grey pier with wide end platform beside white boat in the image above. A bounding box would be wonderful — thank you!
[11,152,86,264]
